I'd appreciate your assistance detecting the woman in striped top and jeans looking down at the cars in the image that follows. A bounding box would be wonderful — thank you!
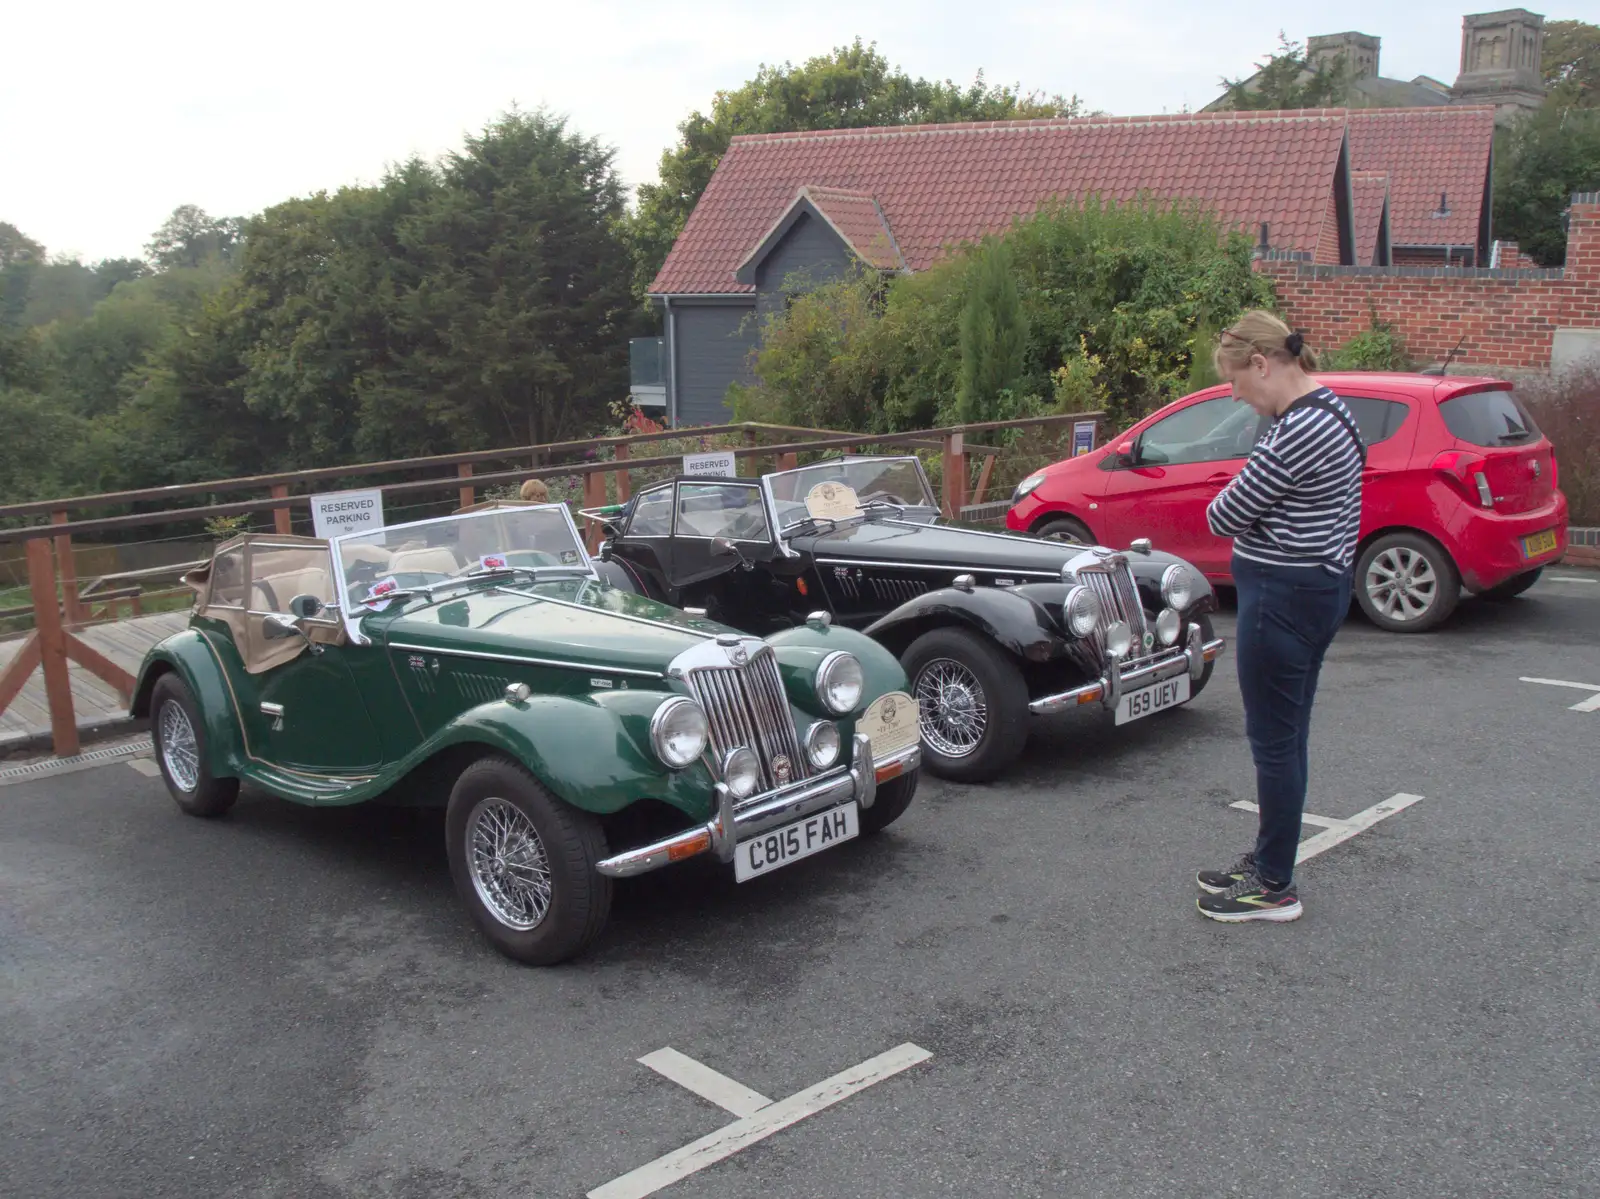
[1198,312,1366,922]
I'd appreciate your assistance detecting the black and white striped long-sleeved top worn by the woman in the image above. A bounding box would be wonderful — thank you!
[1206,387,1363,575]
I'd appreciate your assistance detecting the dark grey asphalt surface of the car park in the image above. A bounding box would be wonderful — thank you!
[0,568,1600,1199]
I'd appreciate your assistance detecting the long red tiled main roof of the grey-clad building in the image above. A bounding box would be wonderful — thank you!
[650,109,1347,295]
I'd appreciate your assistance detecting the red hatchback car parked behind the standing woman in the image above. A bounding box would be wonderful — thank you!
[1006,373,1566,632]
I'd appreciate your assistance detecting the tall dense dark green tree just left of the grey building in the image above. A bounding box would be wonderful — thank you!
[384,110,637,442]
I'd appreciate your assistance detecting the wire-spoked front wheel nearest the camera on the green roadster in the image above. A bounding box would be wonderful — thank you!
[445,756,611,965]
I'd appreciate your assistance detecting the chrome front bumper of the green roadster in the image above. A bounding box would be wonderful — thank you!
[595,733,922,879]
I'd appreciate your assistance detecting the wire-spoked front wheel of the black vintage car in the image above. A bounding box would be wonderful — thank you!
[902,629,1027,784]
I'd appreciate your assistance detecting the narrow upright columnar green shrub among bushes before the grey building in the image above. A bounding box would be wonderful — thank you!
[957,239,1027,423]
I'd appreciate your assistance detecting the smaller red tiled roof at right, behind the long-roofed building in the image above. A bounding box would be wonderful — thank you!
[1350,104,1494,247]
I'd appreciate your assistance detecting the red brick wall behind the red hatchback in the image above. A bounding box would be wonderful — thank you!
[1256,192,1600,370]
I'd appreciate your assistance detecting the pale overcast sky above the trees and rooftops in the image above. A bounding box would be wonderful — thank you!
[0,0,1578,259]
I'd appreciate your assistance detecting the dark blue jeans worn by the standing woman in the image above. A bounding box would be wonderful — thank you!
[1234,554,1350,887]
